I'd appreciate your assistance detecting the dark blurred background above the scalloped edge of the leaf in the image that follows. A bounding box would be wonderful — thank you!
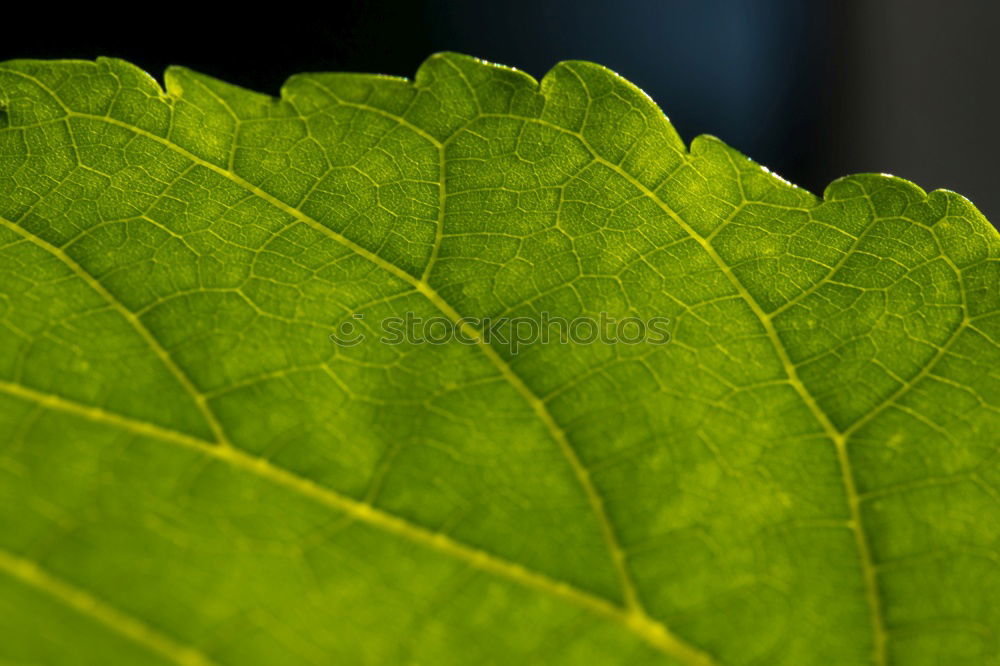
[0,0,1000,223]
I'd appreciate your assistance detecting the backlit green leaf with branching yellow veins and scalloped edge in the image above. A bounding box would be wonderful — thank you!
[0,54,1000,666]
